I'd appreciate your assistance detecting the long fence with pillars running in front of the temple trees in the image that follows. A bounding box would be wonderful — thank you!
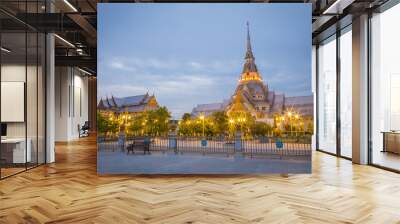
[98,136,311,157]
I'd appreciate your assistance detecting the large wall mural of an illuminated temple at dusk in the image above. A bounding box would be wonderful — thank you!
[97,4,314,174]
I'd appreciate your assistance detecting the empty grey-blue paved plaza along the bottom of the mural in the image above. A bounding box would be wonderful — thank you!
[97,151,311,174]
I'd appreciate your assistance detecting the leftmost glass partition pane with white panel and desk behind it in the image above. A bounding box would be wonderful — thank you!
[0,32,27,177]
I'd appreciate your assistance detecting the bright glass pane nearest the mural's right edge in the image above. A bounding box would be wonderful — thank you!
[317,37,336,153]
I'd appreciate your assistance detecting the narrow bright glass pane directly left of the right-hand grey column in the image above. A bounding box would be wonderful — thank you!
[340,30,352,158]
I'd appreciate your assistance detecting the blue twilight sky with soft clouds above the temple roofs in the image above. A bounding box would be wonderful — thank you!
[97,3,311,118]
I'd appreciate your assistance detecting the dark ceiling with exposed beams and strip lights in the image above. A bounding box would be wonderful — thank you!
[0,0,387,74]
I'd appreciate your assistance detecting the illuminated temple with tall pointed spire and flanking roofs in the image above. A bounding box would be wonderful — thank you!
[192,24,313,120]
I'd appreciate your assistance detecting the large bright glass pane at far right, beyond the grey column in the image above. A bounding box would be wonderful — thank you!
[371,4,400,170]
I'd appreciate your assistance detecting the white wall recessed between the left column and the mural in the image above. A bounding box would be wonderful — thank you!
[55,67,88,141]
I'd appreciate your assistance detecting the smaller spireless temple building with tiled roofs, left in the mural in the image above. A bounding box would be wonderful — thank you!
[97,93,159,114]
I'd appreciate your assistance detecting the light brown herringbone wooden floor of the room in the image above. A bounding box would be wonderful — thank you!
[0,138,400,224]
